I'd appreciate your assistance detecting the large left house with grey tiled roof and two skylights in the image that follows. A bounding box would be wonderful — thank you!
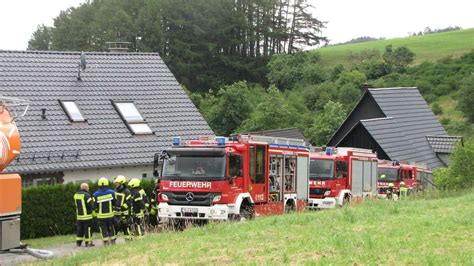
[0,51,213,186]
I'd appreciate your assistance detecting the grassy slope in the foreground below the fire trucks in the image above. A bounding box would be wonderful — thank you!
[38,192,474,265]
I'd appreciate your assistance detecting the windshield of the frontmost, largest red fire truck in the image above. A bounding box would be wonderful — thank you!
[163,155,225,181]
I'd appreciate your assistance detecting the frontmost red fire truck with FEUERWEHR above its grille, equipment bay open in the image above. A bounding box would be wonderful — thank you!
[155,135,309,221]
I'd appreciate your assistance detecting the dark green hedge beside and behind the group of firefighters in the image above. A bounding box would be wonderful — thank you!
[21,180,154,239]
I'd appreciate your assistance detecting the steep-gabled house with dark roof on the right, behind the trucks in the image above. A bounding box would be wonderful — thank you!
[328,88,462,168]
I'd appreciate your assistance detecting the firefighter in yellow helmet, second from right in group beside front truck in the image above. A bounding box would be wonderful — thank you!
[128,178,146,238]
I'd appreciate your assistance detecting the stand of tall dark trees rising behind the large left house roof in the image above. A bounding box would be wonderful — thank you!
[27,0,325,92]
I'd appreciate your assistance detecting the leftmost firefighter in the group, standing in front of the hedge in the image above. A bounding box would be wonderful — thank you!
[74,183,94,247]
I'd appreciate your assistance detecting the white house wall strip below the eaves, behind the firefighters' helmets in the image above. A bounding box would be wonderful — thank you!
[64,165,153,184]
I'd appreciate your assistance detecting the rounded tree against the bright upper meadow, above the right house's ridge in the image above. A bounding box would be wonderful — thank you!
[383,44,415,73]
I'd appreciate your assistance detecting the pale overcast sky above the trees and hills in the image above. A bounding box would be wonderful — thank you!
[0,0,474,50]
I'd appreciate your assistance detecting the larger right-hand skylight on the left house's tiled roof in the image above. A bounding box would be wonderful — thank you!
[113,102,153,135]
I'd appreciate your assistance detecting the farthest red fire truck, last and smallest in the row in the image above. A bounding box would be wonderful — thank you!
[377,161,433,197]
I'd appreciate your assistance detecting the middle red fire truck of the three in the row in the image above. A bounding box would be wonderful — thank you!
[308,147,378,209]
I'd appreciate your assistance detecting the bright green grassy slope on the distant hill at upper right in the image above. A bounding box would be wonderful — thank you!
[314,28,474,66]
